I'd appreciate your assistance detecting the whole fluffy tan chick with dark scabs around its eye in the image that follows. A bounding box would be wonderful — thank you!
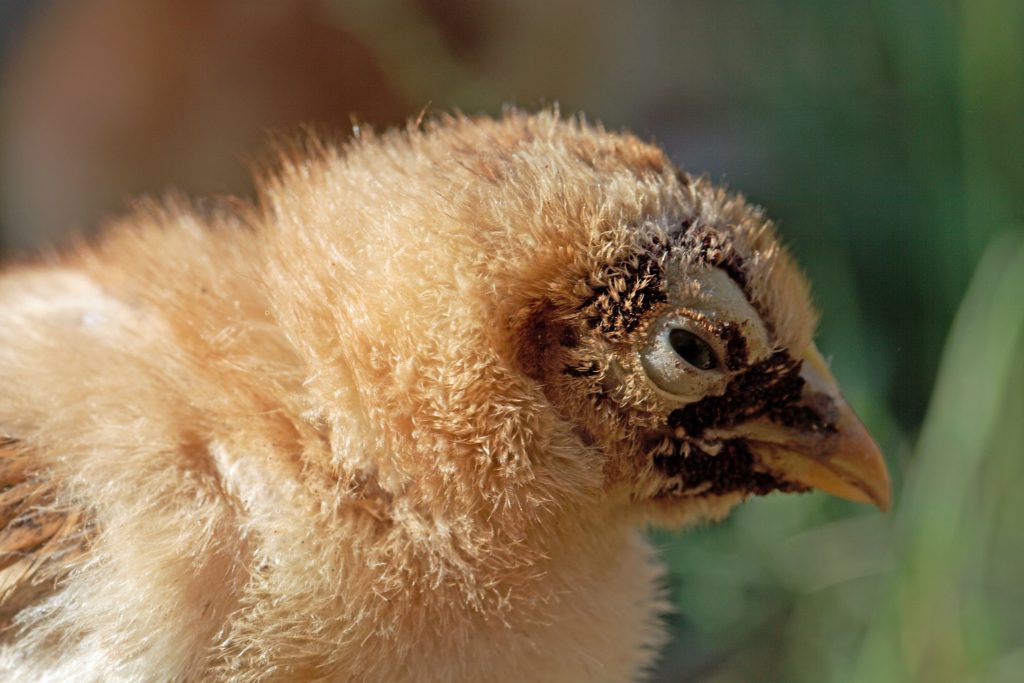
[0,112,889,682]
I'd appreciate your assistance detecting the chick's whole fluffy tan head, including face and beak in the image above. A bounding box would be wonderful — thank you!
[269,112,889,524]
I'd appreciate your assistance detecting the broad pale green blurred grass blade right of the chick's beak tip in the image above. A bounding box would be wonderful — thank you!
[850,234,1024,683]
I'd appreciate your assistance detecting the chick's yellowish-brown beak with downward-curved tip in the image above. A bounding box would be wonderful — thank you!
[744,346,890,511]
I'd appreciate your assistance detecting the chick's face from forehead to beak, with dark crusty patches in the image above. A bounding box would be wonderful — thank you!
[487,121,889,524]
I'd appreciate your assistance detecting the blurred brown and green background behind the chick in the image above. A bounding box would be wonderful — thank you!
[0,0,1024,683]
